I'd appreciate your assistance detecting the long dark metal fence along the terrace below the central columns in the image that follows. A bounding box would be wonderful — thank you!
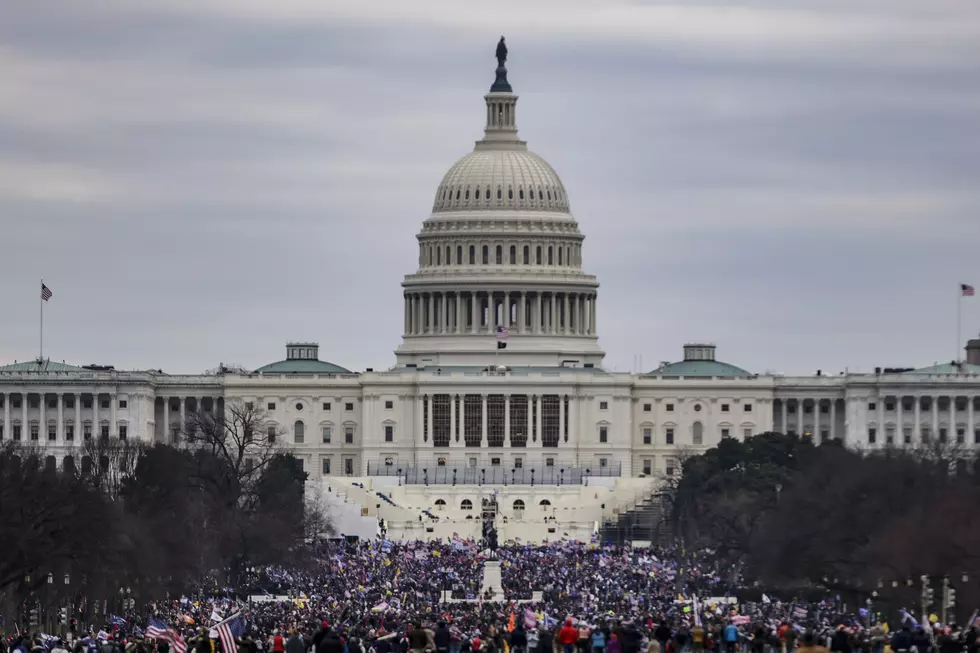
[367,461,623,485]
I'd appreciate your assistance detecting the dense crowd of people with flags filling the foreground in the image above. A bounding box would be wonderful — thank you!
[0,538,980,653]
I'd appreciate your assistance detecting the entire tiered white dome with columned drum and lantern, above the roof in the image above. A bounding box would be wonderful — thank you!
[396,54,603,367]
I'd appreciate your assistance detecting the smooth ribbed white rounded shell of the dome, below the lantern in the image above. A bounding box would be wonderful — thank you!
[432,149,569,213]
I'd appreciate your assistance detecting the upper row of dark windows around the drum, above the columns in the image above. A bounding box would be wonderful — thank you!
[419,244,582,267]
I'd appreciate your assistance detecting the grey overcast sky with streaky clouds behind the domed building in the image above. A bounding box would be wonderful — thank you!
[0,0,980,374]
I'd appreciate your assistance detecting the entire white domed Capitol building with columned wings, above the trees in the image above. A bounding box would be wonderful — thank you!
[0,45,980,496]
